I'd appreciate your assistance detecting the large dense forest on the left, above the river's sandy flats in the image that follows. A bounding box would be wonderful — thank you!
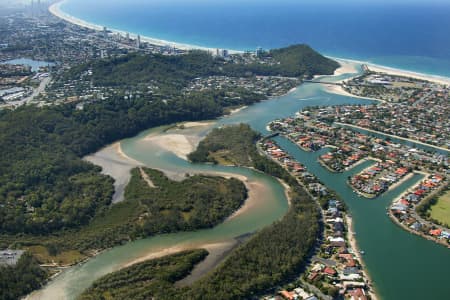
[0,97,222,234]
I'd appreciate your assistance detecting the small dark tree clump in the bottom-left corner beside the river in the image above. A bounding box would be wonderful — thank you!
[0,253,47,300]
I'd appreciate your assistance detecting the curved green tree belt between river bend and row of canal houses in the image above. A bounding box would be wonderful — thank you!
[187,187,319,299]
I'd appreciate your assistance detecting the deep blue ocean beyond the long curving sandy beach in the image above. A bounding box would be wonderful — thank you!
[61,0,450,77]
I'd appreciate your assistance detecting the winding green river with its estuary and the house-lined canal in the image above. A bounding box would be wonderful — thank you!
[35,66,450,299]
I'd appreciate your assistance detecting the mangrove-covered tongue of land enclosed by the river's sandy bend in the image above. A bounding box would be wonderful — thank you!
[0,168,247,255]
